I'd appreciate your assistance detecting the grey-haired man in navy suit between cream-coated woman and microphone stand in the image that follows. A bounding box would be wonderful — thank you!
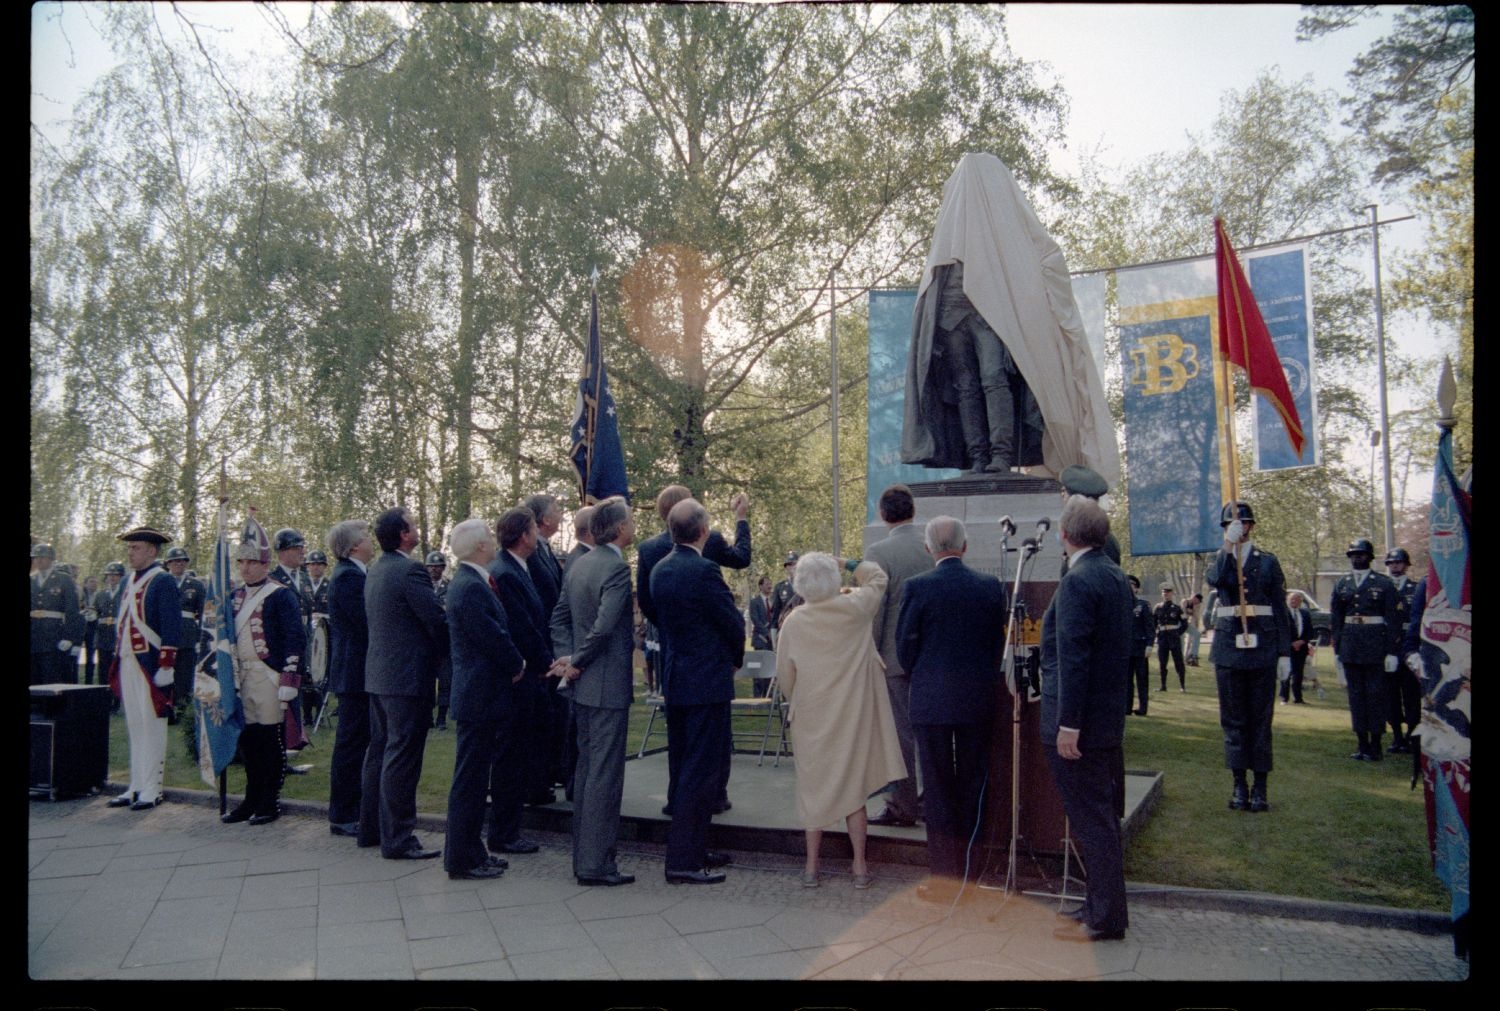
[896,516,1005,902]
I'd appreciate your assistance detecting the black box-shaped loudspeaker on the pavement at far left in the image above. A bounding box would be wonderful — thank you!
[30,684,110,800]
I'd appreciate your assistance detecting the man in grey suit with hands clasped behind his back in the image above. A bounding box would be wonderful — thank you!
[549,498,636,885]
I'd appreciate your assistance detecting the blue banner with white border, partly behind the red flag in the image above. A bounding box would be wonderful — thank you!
[1245,246,1320,471]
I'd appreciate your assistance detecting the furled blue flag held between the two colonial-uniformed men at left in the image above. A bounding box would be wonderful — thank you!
[194,501,246,786]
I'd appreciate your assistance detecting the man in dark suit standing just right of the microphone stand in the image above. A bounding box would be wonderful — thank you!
[1040,497,1136,941]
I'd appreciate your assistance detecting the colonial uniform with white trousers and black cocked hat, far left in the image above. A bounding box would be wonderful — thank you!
[110,527,182,810]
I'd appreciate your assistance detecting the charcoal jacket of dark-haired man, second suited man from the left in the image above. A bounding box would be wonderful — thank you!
[365,551,449,698]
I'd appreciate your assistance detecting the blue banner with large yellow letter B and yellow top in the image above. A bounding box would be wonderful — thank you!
[1121,307,1223,555]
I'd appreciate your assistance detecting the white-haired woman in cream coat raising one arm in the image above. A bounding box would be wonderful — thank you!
[776,552,906,888]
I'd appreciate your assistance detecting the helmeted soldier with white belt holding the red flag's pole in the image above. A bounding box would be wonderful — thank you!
[1203,503,1292,812]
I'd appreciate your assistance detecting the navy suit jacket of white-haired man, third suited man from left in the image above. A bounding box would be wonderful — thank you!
[446,563,525,723]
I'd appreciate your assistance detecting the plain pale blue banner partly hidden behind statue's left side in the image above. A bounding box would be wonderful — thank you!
[864,288,960,524]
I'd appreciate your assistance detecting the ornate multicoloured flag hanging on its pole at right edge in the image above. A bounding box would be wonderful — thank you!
[1419,414,1473,956]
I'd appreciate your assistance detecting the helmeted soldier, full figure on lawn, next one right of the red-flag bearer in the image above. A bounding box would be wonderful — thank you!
[1329,539,1403,762]
